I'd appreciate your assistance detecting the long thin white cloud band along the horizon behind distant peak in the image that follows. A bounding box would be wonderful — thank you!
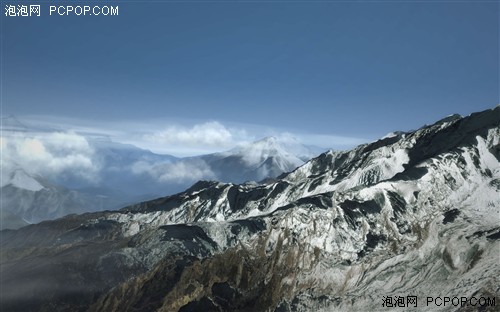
[5,116,373,157]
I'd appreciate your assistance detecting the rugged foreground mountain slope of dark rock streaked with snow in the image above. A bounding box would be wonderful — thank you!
[1,107,500,311]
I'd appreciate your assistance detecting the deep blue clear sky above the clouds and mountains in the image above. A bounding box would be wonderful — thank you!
[1,1,499,154]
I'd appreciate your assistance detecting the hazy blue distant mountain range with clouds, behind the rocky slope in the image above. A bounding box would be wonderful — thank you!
[0,116,320,228]
